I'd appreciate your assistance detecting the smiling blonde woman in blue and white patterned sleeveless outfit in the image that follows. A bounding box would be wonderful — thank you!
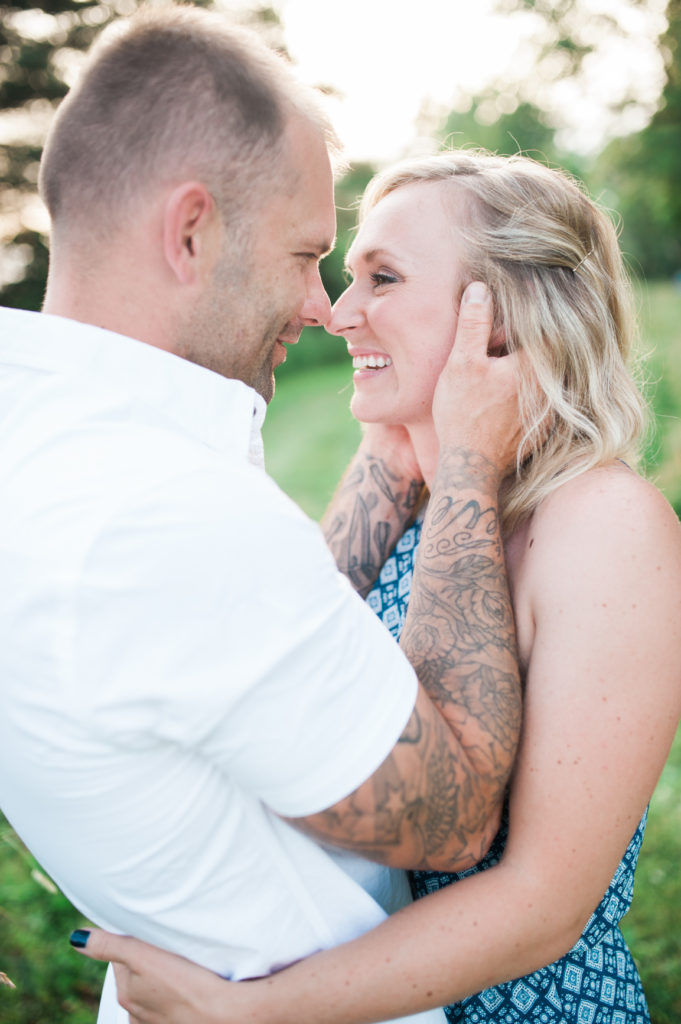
[73,152,681,1024]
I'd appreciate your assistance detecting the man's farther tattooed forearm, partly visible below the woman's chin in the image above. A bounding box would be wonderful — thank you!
[322,424,423,597]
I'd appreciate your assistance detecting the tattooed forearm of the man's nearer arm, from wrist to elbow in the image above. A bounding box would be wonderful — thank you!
[400,447,520,782]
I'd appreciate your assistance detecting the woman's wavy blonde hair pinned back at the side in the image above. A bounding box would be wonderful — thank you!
[359,151,646,534]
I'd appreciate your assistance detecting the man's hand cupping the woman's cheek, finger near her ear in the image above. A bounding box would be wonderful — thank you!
[433,282,524,477]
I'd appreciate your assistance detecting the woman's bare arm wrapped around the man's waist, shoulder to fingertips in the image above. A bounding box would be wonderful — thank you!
[73,468,681,1024]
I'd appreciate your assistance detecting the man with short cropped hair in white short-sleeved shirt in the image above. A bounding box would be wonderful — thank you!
[0,8,519,1020]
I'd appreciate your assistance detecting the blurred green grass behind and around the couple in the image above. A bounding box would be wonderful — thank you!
[0,284,681,1024]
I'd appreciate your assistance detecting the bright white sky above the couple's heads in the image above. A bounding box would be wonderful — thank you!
[273,0,666,163]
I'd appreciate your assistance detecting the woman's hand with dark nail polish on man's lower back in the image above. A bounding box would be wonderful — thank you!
[72,928,238,1024]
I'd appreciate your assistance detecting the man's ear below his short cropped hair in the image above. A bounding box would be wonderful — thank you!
[163,181,219,285]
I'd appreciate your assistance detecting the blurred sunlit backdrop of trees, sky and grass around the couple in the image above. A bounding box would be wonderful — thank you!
[0,0,681,1024]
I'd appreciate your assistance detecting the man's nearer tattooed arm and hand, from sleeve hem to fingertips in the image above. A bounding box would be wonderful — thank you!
[294,284,520,869]
